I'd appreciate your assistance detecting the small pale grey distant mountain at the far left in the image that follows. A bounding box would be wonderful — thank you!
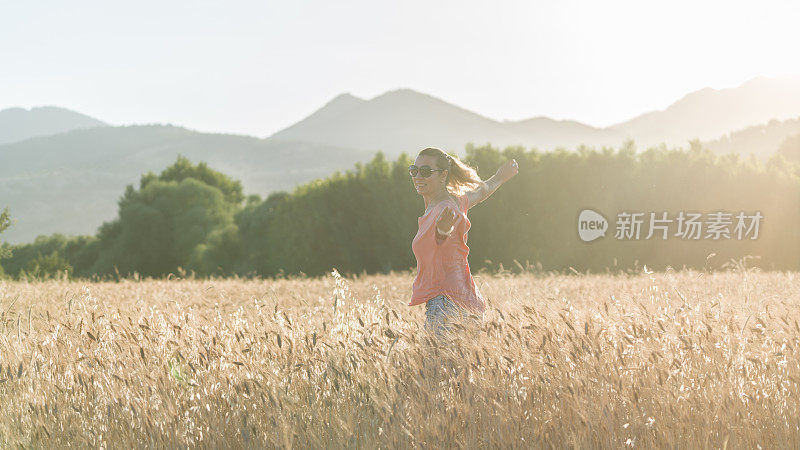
[0,106,107,144]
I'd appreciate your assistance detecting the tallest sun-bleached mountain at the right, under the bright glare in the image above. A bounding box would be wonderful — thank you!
[608,75,800,146]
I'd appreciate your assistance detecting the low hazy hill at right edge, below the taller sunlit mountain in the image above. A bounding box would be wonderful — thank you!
[704,117,800,161]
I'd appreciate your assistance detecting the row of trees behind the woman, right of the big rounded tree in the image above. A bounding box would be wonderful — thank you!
[242,141,800,275]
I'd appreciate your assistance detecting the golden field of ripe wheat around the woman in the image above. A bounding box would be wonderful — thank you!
[0,267,800,448]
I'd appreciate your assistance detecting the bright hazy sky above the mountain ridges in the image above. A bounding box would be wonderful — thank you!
[0,0,800,137]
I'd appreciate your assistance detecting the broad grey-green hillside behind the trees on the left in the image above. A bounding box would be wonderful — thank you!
[0,125,373,243]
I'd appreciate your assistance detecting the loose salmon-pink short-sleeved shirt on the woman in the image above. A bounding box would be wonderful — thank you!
[408,194,486,314]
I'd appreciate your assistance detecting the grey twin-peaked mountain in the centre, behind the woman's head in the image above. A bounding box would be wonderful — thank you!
[269,89,624,157]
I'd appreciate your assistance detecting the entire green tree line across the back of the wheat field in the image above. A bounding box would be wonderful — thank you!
[0,141,800,278]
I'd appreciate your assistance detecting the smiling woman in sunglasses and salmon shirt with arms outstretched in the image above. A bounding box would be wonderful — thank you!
[408,147,518,338]
